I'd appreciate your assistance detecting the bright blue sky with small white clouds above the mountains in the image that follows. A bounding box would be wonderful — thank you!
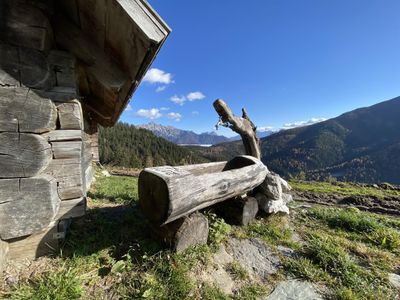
[121,0,400,135]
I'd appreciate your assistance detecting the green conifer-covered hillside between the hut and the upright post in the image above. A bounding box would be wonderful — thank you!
[99,123,205,168]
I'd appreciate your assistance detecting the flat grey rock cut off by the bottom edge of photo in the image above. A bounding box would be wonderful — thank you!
[265,279,322,300]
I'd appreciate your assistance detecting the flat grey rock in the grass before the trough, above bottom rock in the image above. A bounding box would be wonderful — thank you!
[227,238,280,278]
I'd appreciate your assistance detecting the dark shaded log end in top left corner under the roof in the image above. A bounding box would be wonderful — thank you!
[0,0,53,51]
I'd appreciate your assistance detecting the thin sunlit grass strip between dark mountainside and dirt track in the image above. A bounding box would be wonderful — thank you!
[290,180,400,198]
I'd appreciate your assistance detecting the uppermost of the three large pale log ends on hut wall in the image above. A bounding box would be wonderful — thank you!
[0,87,57,133]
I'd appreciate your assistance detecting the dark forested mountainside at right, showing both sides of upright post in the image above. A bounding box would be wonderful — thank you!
[196,97,400,183]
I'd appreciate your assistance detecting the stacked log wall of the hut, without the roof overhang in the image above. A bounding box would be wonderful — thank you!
[0,0,94,270]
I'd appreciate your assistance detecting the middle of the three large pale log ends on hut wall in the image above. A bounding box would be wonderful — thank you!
[0,132,52,178]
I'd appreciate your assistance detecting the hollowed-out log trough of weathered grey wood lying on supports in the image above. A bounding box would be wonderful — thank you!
[139,156,268,224]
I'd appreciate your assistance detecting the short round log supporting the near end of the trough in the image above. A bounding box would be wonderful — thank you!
[150,213,209,252]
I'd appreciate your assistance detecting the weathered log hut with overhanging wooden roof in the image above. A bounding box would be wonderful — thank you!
[0,0,170,269]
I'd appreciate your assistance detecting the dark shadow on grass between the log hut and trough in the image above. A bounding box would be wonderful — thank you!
[63,204,164,260]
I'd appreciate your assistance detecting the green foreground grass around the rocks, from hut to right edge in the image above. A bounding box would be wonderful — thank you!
[0,172,400,300]
